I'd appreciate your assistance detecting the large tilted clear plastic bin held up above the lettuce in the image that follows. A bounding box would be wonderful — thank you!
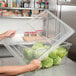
[3,10,74,63]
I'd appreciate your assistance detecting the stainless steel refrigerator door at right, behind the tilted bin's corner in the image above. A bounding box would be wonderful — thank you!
[58,0,76,61]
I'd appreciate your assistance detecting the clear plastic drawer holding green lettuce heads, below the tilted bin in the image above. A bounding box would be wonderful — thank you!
[2,42,72,64]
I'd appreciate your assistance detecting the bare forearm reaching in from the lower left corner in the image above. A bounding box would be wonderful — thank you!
[0,64,37,76]
